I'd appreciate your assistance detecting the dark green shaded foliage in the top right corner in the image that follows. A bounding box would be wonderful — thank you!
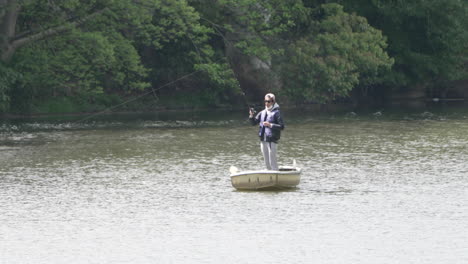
[342,0,468,87]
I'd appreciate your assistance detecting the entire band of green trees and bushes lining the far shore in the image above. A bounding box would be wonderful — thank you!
[0,0,468,117]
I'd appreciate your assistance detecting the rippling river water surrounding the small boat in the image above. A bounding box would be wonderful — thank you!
[0,108,468,264]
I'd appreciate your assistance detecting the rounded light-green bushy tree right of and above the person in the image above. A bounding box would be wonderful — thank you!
[281,4,393,103]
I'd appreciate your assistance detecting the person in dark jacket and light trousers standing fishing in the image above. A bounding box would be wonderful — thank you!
[249,93,284,170]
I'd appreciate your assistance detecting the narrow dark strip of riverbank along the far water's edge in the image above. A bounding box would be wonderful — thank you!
[0,102,468,123]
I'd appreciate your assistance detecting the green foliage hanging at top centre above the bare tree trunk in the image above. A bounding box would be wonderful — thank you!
[204,0,300,62]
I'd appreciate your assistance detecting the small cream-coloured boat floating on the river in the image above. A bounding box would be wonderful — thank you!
[229,161,301,190]
